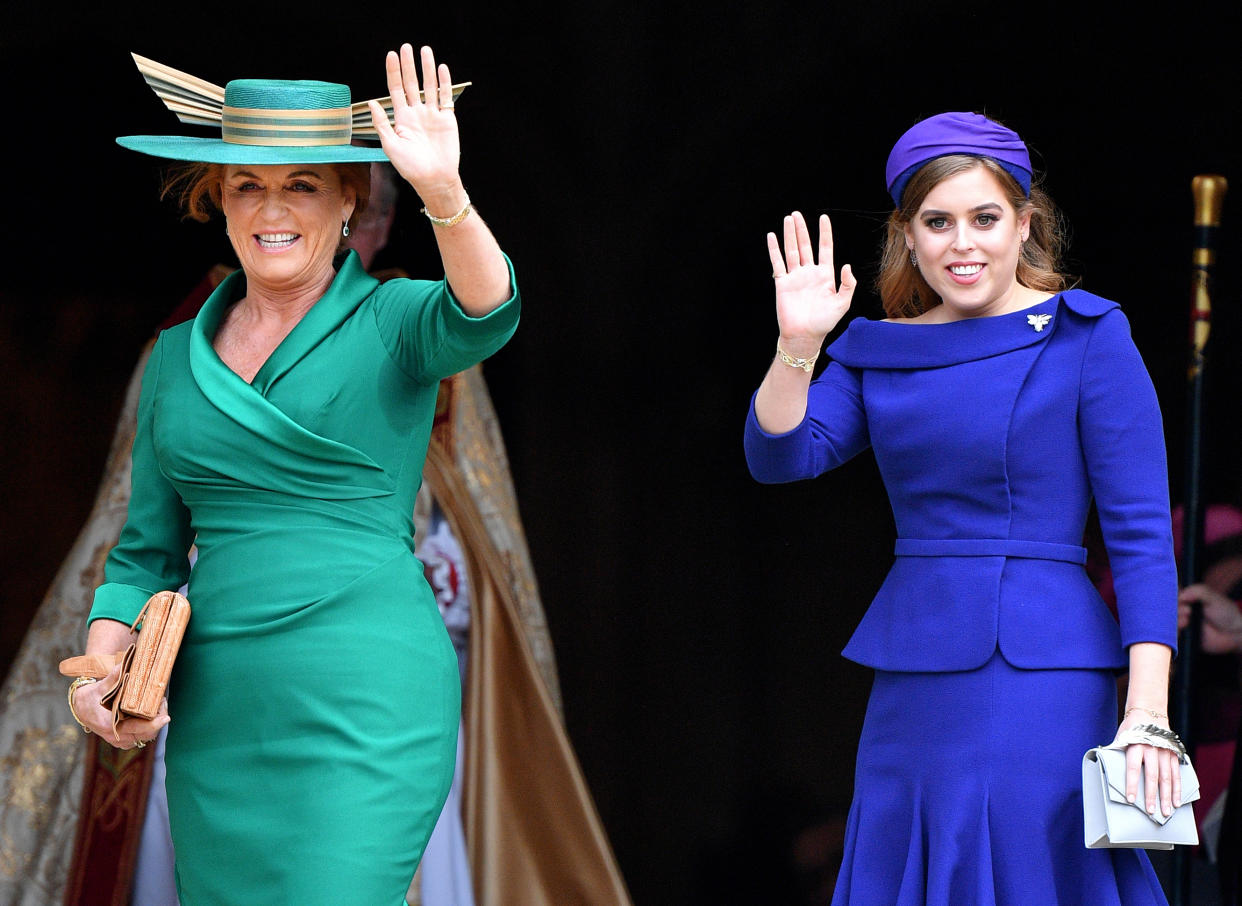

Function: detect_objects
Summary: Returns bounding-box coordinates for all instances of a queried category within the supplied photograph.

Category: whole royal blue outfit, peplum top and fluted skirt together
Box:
[745,290,1177,906]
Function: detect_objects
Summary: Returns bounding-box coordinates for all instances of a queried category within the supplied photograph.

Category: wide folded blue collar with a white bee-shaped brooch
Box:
[827,290,1117,368]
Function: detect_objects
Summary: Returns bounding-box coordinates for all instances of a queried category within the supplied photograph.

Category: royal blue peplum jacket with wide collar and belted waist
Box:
[745,290,1177,671]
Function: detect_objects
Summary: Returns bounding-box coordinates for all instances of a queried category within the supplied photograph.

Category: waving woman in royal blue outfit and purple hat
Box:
[745,113,1180,906]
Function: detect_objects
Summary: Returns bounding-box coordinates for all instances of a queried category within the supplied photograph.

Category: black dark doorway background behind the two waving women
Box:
[0,0,1242,904]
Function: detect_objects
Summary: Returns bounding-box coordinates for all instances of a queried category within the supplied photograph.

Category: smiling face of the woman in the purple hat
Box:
[905,164,1031,318]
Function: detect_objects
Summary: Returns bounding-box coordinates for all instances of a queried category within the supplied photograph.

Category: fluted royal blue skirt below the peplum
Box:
[832,652,1167,906]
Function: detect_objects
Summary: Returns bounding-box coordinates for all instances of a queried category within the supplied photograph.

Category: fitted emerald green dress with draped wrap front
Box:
[91,252,519,906]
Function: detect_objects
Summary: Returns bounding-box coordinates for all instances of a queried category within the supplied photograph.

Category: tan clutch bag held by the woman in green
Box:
[60,592,190,730]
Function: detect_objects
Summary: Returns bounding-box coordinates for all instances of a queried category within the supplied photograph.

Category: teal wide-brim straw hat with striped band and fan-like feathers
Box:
[117,53,469,164]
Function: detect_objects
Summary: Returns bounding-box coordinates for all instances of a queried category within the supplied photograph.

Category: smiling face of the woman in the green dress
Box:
[221,164,355,293]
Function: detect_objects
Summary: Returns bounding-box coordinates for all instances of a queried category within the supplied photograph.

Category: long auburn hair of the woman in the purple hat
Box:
[876,154,1069,318]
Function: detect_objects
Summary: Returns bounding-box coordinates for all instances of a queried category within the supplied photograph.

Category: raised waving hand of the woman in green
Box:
[370,43,461,200]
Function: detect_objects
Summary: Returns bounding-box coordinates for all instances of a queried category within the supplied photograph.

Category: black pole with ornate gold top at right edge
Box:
[1170,174,1228,906]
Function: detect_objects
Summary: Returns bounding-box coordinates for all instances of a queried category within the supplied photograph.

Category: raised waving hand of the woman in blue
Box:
[768,211,858,347]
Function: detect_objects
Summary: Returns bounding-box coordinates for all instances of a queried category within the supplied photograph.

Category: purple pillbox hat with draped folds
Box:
[884,113,1031,208]
